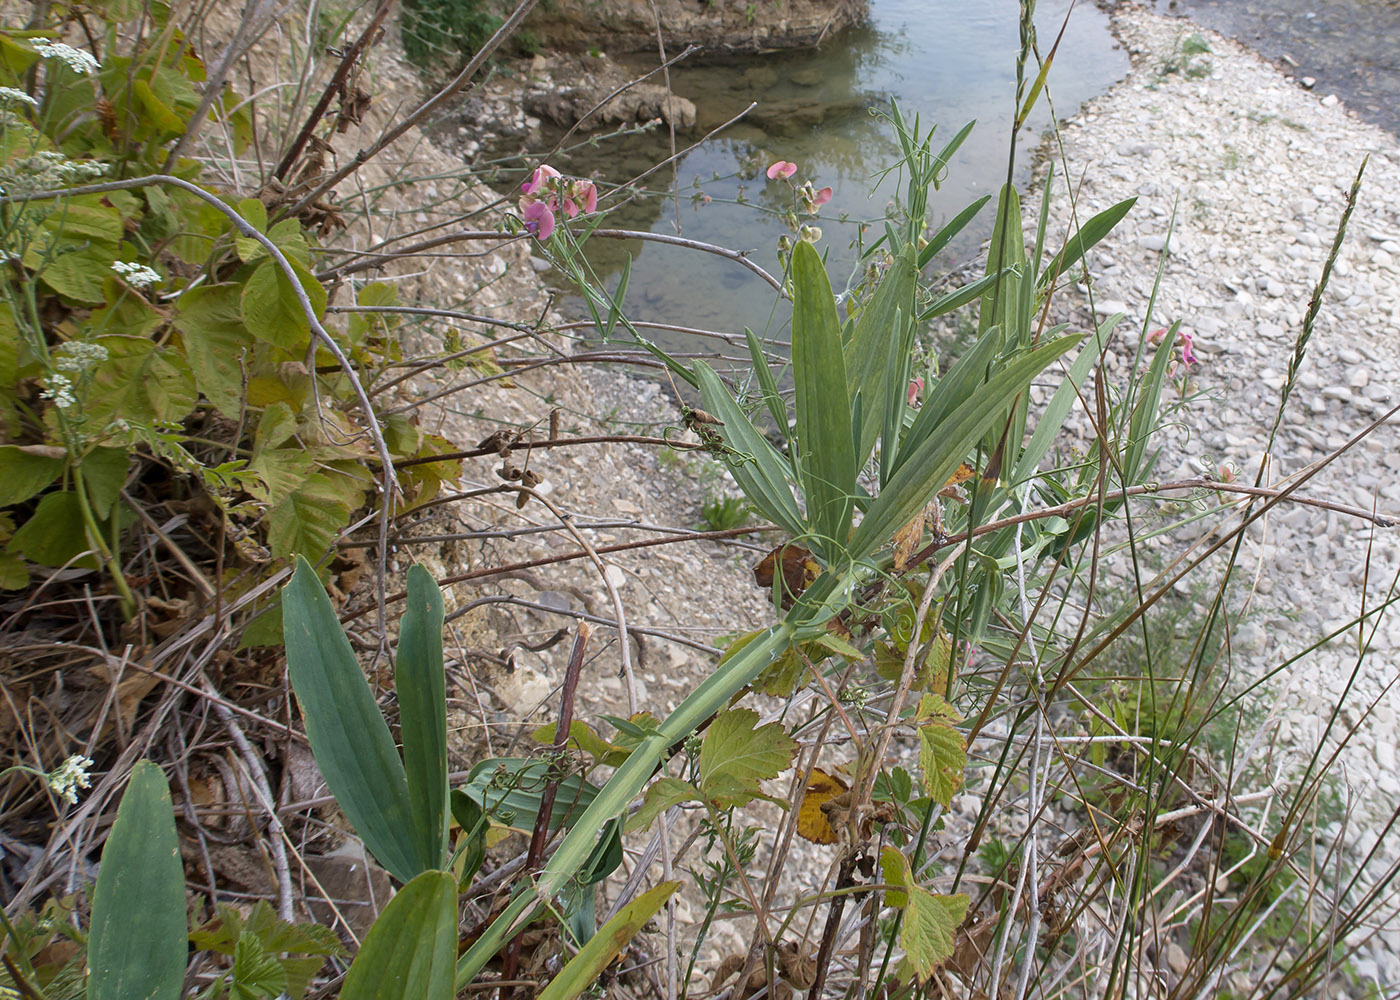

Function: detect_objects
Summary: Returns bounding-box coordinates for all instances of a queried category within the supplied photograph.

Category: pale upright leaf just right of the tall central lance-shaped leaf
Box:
[846,246,918,468]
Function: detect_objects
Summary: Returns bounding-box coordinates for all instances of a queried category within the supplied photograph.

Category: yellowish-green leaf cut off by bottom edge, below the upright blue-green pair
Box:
[340,871,456,1000]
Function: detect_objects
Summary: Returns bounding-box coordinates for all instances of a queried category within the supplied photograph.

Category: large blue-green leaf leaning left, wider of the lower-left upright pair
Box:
[283,557,420,879]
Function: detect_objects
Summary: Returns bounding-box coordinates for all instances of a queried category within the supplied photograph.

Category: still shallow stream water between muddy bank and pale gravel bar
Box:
[534,0,1128,350]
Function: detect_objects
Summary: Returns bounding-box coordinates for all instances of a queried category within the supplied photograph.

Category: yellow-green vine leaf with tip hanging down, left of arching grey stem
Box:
[175,283,253,417]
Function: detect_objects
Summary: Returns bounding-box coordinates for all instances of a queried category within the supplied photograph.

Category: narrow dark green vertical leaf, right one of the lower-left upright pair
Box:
[393,564,448,866]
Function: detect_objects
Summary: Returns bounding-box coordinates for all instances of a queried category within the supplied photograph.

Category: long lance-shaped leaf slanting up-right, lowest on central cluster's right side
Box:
[850,335,1082,559]
